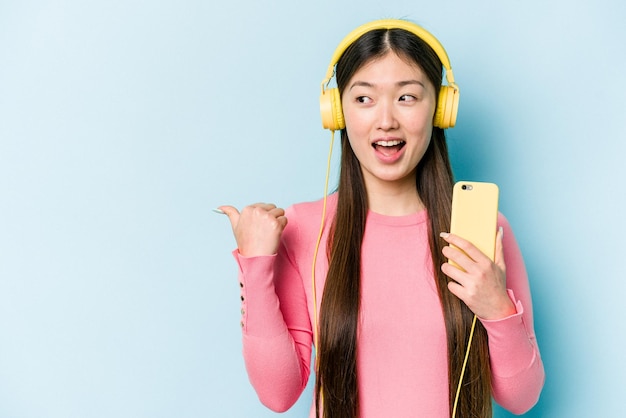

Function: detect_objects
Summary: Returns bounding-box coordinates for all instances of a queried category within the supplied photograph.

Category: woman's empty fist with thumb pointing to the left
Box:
[219,203,287,257]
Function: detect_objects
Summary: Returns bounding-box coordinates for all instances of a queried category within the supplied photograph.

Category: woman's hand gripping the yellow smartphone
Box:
[441,229,516,320]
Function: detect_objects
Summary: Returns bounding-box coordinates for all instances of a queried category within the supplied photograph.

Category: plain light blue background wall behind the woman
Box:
[0,0,626,418]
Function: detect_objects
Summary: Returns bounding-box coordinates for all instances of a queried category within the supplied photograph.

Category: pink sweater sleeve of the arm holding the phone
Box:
[481,215,545,414]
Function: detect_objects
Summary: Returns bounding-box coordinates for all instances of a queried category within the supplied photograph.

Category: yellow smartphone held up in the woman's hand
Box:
[450,181,499,267]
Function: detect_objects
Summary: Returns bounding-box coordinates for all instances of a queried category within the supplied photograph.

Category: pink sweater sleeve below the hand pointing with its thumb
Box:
[233,216,312,412]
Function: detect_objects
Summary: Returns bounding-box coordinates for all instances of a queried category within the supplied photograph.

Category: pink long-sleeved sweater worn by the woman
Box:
[234,195,544,418]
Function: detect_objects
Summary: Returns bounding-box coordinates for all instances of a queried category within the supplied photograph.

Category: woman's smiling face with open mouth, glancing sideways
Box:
[341,52,436,193]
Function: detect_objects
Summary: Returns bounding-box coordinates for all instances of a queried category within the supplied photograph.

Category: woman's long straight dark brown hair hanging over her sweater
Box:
[315,29,492,418]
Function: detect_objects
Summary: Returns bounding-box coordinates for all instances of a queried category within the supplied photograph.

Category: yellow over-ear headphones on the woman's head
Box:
[320,19,459,131]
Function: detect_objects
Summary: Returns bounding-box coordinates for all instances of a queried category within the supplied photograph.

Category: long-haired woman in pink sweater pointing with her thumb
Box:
[219,20,544,418]
